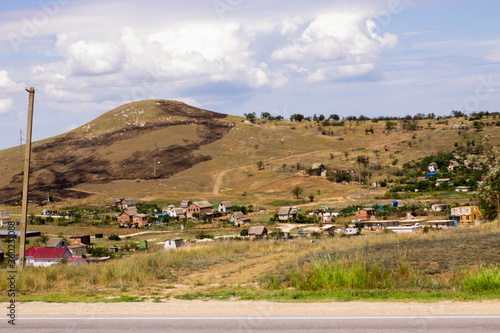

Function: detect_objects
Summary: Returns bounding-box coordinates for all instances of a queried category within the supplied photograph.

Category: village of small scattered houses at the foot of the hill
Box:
[0,188,483,266]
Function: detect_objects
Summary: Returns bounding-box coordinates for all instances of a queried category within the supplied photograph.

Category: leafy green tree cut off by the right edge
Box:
[476,137,500,228]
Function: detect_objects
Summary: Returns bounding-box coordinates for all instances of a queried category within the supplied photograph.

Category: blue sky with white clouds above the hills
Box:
[0,0,500,149]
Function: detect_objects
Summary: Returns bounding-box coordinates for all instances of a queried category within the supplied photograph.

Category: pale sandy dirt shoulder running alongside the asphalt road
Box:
[8,299,500,321]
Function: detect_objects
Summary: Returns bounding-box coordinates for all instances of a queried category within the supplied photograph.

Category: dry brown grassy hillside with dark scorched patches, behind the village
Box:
[0,100,500,210]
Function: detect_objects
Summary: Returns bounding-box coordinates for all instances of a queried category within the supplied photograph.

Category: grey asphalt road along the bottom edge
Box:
[0,315,500,333]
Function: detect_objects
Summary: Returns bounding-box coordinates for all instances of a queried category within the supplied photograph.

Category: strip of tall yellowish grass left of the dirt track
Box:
[0,241,288,293]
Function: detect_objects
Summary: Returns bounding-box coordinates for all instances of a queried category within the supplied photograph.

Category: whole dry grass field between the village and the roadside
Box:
[0,229,500,298]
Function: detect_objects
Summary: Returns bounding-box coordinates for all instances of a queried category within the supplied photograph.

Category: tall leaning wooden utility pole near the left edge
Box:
[19,87,35,269]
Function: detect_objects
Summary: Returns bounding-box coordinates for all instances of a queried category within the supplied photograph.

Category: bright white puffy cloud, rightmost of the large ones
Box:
[272,11,398,80]
